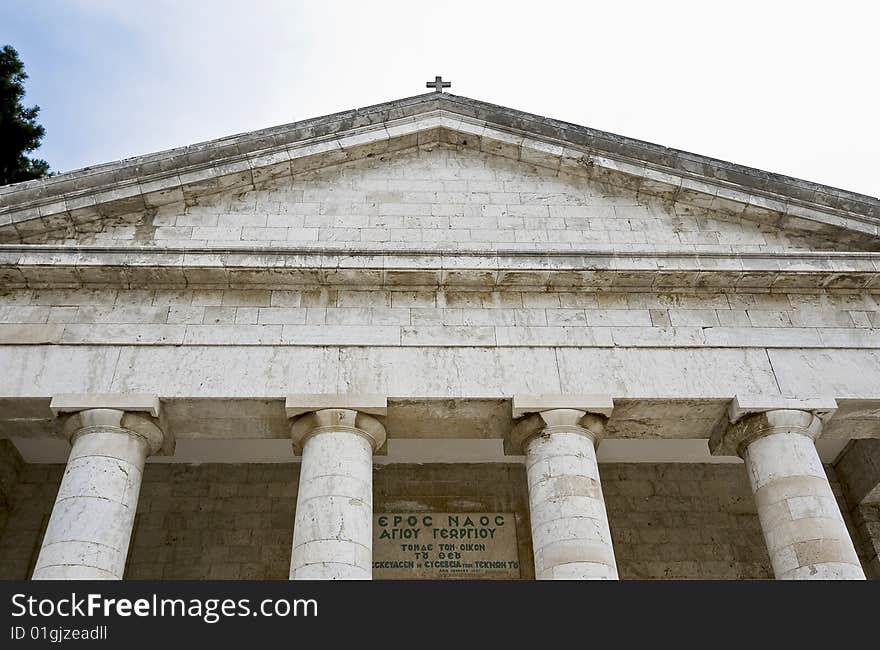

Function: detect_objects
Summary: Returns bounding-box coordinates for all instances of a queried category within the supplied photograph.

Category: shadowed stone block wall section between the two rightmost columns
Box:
[599,463,773,580]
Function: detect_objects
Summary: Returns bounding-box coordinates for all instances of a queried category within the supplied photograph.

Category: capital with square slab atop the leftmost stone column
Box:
[49,393,174,456]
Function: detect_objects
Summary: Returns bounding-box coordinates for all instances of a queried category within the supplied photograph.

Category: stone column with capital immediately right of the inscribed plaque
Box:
[506,396,618,580]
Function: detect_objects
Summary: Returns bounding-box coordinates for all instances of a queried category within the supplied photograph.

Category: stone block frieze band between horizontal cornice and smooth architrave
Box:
[0,286,880,350]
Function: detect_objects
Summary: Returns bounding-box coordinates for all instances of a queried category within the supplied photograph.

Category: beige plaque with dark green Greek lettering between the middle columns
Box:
[373,512,520,580]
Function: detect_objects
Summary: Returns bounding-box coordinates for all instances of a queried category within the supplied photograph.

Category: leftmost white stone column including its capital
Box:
[33,396,164,580]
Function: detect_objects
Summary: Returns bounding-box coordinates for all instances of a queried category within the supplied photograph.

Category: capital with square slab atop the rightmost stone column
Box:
[709,396,837,457]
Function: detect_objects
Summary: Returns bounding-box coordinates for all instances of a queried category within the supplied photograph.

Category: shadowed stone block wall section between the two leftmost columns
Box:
[126,464,299,580]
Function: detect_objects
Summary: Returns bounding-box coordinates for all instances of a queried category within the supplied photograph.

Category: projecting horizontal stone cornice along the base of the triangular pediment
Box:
[0,244,880,291]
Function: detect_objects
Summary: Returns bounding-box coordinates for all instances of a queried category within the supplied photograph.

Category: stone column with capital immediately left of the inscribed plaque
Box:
[287,396,385,580]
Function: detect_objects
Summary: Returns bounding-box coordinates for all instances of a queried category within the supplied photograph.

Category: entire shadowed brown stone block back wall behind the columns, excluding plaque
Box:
[0,463,880,579]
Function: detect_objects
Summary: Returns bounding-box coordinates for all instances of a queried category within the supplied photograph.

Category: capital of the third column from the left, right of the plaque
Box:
[504,395,614,456]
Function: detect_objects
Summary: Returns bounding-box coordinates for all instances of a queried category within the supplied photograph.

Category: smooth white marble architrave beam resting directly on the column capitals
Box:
[0,345,880,399]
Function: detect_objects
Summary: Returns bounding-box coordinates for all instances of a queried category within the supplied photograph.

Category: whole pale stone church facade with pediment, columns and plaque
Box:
[0,87,880,580]
